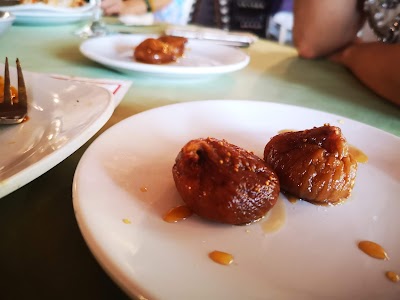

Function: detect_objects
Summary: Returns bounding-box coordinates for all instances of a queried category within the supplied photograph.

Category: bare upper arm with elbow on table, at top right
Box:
[293,0,364,58]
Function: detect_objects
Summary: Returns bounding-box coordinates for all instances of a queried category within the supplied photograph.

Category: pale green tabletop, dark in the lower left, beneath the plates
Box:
[0,19,400,299]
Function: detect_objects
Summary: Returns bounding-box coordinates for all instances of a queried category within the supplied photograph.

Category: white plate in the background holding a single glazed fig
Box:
[80,34,250,78]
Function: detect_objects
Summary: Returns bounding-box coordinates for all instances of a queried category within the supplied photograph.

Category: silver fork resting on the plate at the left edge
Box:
[0,58,28,124]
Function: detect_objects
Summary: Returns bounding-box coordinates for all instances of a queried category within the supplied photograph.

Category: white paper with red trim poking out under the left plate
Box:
[50,74,132,107]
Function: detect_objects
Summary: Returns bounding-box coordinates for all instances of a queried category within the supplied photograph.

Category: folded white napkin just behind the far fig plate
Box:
[165,25,258,46]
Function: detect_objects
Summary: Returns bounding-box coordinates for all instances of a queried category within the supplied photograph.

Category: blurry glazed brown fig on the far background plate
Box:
[134,36,187,64]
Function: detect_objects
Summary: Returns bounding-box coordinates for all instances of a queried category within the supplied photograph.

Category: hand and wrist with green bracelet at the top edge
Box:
[102,0,171,15]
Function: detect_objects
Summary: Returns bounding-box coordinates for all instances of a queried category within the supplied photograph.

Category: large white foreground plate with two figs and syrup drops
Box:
[73,100,400,300]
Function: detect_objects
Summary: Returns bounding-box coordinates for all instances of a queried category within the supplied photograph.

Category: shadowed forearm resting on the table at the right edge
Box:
[331,42,400,105]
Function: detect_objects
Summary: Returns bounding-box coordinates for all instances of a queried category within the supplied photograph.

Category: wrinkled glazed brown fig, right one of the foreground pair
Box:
[264,124,357,204]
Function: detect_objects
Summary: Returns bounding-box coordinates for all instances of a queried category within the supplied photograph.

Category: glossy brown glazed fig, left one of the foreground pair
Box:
[172,138,279,225]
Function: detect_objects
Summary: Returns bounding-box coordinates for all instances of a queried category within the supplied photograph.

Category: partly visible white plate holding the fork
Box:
[0,62,114,197]
